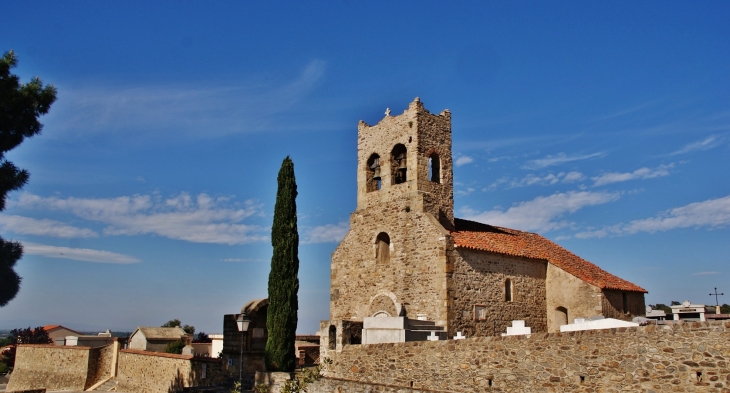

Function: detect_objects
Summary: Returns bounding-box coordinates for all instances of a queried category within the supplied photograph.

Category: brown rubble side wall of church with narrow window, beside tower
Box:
[448,248,547,337]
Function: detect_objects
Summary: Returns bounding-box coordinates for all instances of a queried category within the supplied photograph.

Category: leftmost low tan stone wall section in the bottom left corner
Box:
[7,344,90,391]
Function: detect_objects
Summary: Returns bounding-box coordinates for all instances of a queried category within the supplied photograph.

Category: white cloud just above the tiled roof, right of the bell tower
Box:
[462,191,619,232]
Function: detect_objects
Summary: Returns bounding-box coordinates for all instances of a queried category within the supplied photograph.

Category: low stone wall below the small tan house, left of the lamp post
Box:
[117,349,223,393]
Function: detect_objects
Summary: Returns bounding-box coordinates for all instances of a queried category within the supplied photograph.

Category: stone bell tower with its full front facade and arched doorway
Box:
[320,98,454,356]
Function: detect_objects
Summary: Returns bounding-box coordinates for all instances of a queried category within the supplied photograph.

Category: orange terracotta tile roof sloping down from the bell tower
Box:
[451,218,648,293]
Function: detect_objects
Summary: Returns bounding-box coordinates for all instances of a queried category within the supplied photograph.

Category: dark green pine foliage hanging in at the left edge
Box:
[0,51,56,307]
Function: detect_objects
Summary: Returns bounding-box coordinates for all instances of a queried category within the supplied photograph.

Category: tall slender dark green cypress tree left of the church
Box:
[265,156,299,372]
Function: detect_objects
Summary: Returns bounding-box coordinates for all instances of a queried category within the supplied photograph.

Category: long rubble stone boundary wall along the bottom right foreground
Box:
[310,322,730,393]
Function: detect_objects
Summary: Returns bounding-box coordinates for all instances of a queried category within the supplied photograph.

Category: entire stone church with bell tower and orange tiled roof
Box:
[320,98,647,356]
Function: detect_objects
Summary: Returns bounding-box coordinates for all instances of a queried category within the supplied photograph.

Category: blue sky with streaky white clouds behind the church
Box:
[0,1,730,333]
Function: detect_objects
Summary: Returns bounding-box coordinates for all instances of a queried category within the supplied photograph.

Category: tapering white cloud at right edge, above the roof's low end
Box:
[575,195,730,239]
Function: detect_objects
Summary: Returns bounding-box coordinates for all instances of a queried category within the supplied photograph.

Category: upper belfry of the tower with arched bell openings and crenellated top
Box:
[357,97,454,228]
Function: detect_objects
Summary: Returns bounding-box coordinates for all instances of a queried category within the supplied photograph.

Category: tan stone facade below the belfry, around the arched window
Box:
[330,204,451,325]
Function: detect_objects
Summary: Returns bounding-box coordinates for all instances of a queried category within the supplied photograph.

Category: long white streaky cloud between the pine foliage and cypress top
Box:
[16,193,267,245]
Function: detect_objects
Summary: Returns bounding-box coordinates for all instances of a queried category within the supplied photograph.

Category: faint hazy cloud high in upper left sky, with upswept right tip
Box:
[44,60,326,137]
